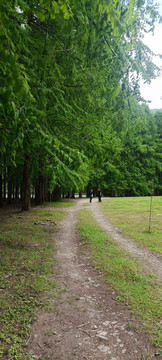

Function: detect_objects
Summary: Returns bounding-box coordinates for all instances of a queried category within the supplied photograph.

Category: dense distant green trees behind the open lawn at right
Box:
[90,99,162,196]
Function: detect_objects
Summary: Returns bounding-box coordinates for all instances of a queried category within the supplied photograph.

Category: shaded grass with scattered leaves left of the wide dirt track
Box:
[0,209,65,360]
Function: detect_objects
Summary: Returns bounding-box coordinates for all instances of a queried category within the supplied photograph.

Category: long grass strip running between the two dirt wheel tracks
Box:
[78,210,162,352]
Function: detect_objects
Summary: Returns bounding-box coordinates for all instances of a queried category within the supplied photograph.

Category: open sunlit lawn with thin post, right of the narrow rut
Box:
[101,196,162,254]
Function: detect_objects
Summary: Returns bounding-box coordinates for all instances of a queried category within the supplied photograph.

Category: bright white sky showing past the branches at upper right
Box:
[140,0,162,109]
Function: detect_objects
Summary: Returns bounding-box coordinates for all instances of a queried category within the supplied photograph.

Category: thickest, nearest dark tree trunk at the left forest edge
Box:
[22,155,31,211]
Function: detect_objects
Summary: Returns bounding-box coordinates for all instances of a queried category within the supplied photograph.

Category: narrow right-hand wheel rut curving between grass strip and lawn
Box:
[90,200,162,281]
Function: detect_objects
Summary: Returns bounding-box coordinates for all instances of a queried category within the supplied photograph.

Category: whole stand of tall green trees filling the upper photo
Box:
[0,0,162,210]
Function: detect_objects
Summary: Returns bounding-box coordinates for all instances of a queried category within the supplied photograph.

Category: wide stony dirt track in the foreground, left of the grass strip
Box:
[27,200,161,360]
